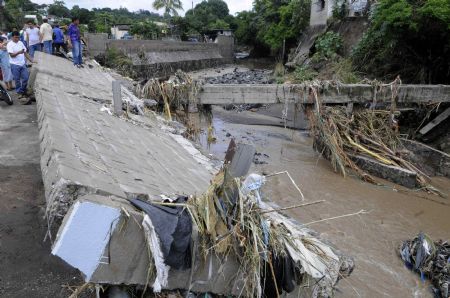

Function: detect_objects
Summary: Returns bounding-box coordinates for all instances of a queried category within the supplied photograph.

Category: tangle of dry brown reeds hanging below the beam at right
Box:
[308,95,439,193]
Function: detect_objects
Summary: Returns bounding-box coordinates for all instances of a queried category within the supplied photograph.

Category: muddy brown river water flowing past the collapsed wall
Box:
[200,108,450,297]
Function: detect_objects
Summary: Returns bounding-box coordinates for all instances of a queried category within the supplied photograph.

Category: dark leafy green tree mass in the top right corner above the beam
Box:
[353,0,450,83]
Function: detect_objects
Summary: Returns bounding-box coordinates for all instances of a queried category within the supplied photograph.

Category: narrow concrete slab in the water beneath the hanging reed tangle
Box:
[350,155,417,188]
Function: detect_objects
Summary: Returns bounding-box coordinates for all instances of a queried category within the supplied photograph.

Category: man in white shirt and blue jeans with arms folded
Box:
[6,31,33,97]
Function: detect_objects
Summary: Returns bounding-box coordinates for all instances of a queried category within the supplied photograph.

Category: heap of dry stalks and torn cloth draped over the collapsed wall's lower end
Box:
[133,170,353,297]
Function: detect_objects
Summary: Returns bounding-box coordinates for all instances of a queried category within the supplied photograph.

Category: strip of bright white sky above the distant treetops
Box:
[32,0,252,15]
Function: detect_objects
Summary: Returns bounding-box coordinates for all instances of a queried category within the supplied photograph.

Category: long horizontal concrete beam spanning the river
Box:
[199,84,450,105]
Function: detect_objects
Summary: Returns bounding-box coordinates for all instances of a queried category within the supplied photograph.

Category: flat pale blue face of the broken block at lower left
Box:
[52,202,120,281]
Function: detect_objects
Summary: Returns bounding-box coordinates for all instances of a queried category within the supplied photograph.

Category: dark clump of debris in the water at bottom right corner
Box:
[400,233,450,298]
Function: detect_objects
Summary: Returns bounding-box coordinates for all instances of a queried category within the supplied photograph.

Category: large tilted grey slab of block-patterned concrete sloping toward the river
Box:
[34,53,212,224]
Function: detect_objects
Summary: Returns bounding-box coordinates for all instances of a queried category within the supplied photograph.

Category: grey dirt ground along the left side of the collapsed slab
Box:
[0,102,82,298]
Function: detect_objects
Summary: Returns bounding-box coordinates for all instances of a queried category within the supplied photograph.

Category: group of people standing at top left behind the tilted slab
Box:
[0,17,83,98]
